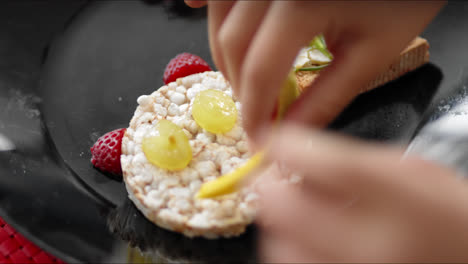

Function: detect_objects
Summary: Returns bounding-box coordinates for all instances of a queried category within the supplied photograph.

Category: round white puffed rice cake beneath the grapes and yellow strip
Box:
[121,72,257,238]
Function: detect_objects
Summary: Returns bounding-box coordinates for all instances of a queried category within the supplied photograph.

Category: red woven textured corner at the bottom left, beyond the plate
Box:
[0,218,64,263]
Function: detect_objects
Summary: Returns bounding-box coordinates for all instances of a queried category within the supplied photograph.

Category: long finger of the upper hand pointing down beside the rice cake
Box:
[239,1,322,143]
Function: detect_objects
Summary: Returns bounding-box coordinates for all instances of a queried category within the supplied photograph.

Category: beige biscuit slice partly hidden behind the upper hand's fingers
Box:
[296,37,429,92]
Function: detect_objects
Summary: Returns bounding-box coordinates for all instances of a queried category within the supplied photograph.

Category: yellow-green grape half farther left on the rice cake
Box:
[142,120,192,171]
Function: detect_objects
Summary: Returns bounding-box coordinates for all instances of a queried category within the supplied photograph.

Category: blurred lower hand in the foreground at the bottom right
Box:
[259,125,468,263]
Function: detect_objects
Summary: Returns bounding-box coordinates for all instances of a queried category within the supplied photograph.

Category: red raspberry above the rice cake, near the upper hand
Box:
[163,53,211,84]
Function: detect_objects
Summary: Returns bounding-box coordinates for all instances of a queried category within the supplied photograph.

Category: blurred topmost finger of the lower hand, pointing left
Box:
[268,125,401,191]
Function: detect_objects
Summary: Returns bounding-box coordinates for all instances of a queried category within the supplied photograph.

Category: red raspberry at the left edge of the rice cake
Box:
[91,128,126,176]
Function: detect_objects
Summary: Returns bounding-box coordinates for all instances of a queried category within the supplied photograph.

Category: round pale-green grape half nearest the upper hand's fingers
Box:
[192,89,237,134]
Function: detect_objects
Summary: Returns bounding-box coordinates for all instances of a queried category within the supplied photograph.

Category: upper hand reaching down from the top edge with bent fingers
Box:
[186,0,444,143]
